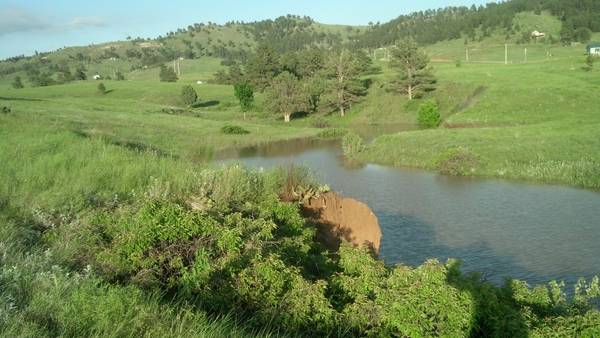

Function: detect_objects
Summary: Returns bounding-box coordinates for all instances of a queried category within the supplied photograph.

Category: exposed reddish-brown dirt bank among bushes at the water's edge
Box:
[303,192,381,253]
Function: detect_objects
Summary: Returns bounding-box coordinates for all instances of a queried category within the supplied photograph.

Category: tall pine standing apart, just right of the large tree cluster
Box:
[390,39,436,100]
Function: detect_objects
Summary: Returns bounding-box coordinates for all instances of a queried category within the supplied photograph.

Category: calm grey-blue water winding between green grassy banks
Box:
[218,140,600,285]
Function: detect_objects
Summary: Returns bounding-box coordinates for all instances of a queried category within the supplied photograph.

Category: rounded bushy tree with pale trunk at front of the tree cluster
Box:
[267,72,307,123]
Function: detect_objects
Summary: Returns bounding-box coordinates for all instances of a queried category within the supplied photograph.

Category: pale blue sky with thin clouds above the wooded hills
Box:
[0,0,491,58]
